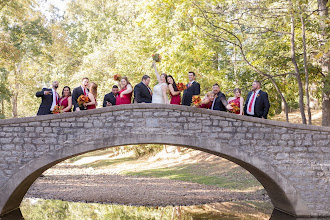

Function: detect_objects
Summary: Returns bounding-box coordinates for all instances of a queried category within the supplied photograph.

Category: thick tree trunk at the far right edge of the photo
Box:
[317,0,330,126]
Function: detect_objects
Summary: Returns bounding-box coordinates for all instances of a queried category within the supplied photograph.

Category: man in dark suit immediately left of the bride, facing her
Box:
[134,75,152,103]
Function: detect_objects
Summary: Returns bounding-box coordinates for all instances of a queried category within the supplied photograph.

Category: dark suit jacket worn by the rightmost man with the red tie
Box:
[244,90,270,118]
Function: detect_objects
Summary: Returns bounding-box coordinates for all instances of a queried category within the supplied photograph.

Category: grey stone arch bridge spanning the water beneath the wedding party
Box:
[0,104,330,217]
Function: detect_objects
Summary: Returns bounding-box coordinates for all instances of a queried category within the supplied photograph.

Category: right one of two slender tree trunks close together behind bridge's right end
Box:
[300,14,312,125]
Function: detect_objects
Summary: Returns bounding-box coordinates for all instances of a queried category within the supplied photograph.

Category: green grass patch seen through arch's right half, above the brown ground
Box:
[123,164,260,190]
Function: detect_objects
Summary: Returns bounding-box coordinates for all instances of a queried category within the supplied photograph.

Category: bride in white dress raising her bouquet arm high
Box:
[152,61,170,104]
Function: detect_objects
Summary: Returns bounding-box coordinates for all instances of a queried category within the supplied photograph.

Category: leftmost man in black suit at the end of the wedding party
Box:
[36,81,60,115]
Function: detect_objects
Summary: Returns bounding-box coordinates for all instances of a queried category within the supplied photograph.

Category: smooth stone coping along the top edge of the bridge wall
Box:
[0,103,330,132]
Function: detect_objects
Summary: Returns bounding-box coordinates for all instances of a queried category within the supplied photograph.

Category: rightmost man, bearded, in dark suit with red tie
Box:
[244,81,270,119]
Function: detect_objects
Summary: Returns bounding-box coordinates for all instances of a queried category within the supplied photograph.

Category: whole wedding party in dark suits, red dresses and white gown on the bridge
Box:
[36,61,270,119]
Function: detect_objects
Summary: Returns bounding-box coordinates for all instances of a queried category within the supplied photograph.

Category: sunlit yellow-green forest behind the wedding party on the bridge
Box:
[0,0,330,126]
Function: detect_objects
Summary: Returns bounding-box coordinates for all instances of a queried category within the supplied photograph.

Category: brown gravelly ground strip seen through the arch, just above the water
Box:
[26,175,266,206]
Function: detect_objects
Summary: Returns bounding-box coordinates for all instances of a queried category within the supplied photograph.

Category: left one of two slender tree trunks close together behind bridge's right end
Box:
[291,14,306,124]
